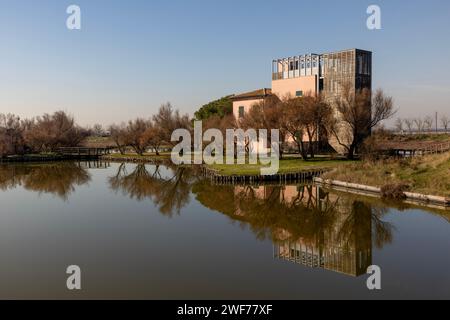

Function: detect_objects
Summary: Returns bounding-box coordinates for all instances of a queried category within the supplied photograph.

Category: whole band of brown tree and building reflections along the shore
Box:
[0,162,444,276]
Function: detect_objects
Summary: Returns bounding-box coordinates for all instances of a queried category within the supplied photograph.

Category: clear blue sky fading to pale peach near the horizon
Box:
[0,0,450,125]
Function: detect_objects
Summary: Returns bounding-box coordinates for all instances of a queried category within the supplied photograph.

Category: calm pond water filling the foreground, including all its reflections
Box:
[0,162,450,299]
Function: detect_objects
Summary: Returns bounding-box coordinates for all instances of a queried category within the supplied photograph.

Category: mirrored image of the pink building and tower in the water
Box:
[234,186,372,276]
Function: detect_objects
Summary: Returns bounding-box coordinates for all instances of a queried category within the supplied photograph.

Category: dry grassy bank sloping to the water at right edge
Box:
[324,153,450,197]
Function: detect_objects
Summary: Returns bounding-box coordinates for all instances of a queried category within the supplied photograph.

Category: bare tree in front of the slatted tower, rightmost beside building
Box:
[330,85,396,159]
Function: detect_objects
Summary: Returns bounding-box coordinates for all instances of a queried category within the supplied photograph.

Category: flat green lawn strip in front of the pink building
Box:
[209,157,353,176]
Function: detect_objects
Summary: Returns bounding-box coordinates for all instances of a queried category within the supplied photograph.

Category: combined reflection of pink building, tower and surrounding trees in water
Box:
[193,183,393,276]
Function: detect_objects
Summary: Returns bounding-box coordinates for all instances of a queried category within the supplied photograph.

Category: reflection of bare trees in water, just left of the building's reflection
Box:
[109,163,194,216]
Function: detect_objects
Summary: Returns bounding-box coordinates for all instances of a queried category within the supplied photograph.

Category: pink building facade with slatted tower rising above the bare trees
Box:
[233,49,372,152]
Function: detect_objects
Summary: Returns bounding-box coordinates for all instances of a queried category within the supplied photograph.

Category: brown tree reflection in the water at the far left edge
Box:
[0,162,91,200]
